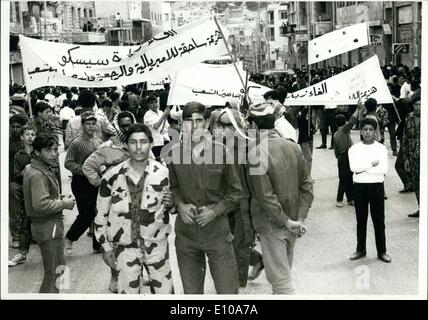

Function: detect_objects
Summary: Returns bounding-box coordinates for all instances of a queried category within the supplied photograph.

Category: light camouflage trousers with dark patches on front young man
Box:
[115,239,174,294]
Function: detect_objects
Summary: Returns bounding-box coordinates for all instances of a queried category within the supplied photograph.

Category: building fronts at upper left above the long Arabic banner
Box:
[9,1,152,85]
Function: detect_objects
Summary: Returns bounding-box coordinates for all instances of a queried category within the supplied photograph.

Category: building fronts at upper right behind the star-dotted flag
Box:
[285,1,422,69]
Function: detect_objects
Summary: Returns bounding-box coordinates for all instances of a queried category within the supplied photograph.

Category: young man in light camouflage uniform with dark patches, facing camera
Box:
[95,124,174,294]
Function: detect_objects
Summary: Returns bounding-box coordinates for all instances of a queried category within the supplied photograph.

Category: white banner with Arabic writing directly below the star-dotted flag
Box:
[285,55,393,106]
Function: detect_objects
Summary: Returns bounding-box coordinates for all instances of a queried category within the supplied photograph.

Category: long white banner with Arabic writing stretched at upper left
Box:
[20,18,227,92]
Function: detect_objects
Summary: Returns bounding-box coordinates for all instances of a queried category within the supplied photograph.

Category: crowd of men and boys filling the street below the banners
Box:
[9,58,420,294]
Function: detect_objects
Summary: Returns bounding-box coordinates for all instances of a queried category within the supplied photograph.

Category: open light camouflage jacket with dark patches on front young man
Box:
[95,159,171,251]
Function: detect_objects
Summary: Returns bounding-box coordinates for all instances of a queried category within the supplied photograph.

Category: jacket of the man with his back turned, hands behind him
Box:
[247,130,313,234]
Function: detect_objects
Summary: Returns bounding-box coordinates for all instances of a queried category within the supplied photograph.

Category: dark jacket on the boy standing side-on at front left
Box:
[23,158,63,222]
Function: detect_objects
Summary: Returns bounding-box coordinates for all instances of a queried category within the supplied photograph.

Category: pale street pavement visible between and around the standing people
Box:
[8,131,419,295]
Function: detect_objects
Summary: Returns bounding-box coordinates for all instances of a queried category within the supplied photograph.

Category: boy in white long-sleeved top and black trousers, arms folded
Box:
[348,118,391,263]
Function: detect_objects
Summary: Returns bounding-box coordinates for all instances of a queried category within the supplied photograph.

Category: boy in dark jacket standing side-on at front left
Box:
[23,133,74,293]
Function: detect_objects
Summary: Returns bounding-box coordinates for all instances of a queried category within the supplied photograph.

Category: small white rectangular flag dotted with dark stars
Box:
[308,22,369,64]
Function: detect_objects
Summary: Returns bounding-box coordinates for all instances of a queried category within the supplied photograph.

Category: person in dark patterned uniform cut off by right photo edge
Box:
[400,94,421,218]
